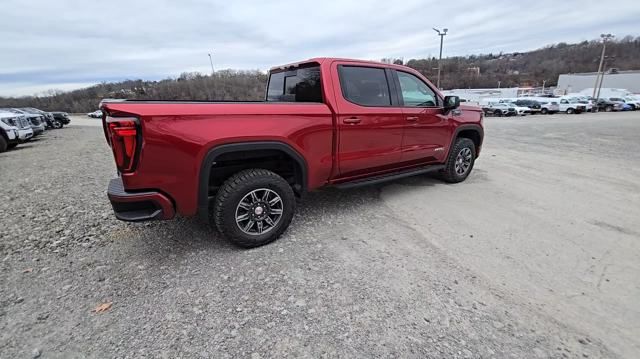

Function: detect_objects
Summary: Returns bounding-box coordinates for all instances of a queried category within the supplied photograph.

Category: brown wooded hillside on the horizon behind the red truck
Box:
[0,36,640,112]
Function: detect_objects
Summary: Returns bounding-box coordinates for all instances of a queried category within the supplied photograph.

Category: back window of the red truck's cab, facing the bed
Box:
[267,65,322,102]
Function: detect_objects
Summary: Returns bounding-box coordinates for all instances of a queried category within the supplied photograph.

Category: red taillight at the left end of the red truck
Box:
[106,117,140,173]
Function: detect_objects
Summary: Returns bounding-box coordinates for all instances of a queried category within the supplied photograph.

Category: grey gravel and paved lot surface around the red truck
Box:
[0,113,640,358]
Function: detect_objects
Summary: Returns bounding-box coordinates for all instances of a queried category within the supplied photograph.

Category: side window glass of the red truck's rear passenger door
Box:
[339,66,391,106]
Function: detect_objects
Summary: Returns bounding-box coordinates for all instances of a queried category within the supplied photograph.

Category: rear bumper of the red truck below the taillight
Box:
[107,178,176,222]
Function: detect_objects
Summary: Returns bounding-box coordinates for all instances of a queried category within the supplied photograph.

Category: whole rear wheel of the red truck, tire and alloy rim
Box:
[213,168,296,248]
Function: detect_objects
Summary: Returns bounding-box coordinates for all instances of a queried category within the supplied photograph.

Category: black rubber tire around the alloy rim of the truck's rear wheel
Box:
[213,168,296,248]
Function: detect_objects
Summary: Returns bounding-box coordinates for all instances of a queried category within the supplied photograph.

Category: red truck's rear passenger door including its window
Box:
[332,62,405,177]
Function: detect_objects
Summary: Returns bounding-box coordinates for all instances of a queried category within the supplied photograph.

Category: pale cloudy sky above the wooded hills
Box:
[0,0,640,96]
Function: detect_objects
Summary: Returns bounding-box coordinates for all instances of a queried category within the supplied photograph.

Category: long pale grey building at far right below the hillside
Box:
[557,70,640,93]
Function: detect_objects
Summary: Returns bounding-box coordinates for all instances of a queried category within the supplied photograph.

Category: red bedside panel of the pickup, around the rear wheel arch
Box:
[104,103,333,216]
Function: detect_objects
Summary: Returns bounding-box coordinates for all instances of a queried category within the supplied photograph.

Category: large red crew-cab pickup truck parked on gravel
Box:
[101,58,484,247]
